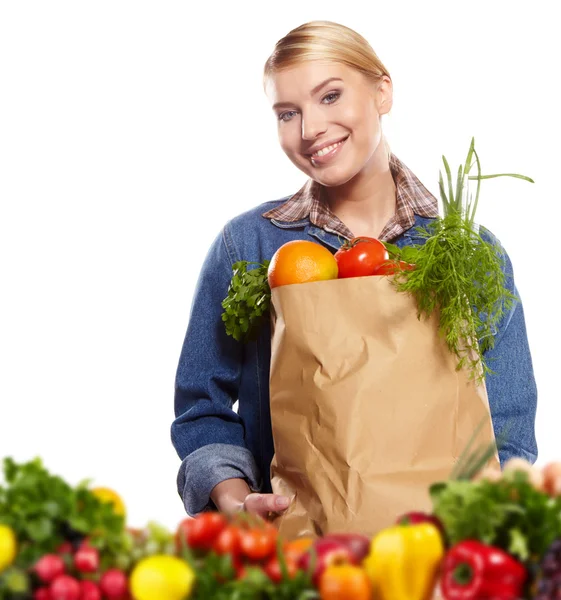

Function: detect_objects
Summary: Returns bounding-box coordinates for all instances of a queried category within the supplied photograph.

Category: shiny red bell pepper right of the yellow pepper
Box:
[441,540,527,600]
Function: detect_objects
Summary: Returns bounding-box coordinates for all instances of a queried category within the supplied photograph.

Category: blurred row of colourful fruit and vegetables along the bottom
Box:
[0,455,561,600]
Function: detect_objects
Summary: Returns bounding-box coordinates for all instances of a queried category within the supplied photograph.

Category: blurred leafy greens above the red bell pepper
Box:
[430,471,561,562]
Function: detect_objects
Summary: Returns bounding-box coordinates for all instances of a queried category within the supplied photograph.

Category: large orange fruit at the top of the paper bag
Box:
[268,240,339,289]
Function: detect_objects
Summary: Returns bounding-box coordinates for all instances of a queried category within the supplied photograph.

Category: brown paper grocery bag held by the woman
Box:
[270,277,500,539]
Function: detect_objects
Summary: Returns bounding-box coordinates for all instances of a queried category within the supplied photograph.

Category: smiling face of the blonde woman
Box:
[266,61,392,187]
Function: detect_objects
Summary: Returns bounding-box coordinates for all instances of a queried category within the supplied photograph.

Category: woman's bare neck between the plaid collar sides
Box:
[324,144,396,237]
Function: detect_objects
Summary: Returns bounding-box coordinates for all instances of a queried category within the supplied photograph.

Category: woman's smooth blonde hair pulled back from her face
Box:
[263,21,391,155]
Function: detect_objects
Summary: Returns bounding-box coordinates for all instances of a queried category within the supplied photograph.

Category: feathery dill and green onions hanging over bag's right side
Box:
[386,138,533,380]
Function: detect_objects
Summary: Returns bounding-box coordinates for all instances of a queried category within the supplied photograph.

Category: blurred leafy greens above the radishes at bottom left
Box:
[0,458,124,568]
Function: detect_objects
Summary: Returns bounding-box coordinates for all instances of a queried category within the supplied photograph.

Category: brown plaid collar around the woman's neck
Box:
[263,154,438,241]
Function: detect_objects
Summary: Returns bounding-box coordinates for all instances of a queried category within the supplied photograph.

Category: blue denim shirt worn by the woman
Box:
[171,196,537,515]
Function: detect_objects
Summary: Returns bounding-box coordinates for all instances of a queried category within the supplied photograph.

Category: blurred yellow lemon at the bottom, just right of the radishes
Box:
[130,554,195,600]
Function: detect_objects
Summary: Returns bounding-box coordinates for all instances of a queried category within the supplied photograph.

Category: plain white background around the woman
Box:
[0,0,561,527]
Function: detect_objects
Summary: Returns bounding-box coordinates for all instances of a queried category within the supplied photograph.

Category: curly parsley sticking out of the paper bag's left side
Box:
[222,260,271,342]
